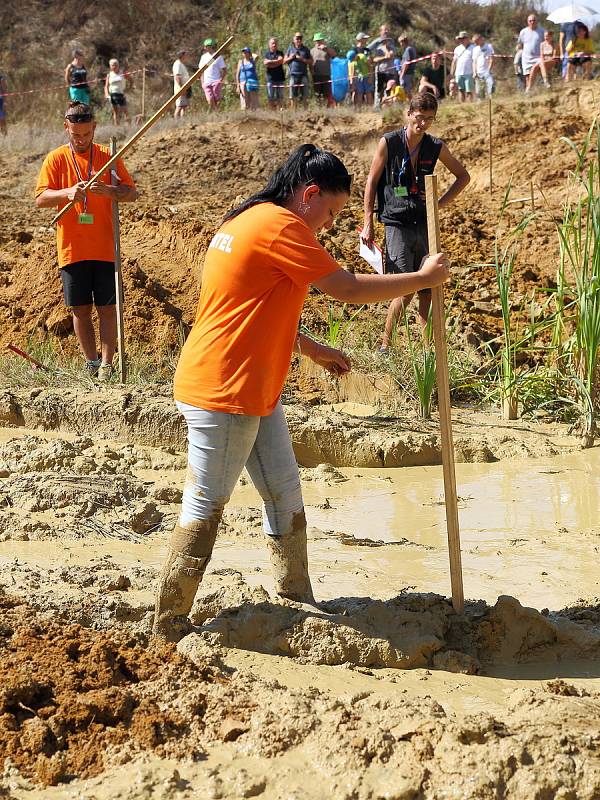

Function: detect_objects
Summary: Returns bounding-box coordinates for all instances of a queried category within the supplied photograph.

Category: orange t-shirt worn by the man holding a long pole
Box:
[35,144,135,267]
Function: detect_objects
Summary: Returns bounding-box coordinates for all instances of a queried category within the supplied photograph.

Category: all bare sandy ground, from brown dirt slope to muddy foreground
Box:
[0,86,600,800]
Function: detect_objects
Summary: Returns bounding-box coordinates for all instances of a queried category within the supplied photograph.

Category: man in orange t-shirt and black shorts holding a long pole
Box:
[35,103,137,380]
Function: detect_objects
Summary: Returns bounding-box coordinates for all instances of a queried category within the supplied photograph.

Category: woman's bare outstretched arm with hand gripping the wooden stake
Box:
[315,253,449,303]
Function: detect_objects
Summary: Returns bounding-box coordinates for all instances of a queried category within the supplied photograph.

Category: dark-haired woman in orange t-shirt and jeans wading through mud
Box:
[153,145,448,641]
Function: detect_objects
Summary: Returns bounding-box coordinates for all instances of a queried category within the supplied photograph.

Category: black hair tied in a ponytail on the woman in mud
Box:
[223,144,352,222]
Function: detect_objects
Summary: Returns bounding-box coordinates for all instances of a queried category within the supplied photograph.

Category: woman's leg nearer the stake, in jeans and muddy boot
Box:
[246,403,314,602]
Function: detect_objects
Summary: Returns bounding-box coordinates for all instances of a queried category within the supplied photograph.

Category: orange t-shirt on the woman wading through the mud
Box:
[174,203,340,416]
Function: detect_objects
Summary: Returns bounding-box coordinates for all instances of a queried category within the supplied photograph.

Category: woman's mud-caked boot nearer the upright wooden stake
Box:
[267,511,315,603]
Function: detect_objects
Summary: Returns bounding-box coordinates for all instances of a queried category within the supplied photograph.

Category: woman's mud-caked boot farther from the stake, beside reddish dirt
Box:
[152,519,219,642]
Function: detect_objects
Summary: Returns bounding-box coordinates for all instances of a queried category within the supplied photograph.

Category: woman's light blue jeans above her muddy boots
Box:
[177,402,304,536]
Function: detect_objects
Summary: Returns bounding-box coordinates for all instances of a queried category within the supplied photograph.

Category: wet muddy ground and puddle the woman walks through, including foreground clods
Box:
[0,392,600,800]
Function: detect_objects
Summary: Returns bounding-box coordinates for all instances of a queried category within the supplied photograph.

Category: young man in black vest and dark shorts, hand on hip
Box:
[360,92,470,352]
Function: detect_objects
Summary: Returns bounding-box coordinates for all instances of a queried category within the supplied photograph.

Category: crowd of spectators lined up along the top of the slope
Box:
[0,13,595,133]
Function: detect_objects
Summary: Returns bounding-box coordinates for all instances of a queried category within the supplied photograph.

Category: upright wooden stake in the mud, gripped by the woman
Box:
[425,175,465,614]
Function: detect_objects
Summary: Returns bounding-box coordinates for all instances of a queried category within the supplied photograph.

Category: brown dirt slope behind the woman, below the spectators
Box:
[0,88,594,356]
